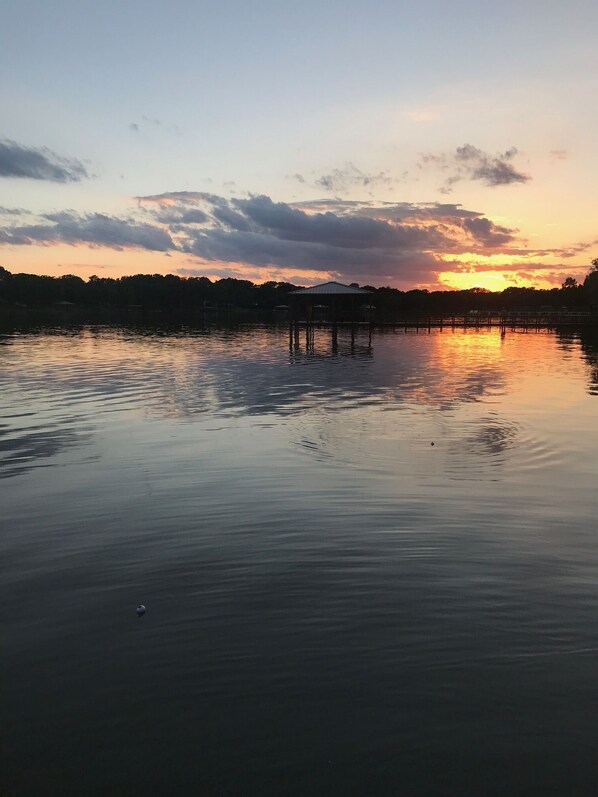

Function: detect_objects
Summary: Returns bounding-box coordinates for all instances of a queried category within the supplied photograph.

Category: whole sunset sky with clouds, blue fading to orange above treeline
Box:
[0,0,598,290]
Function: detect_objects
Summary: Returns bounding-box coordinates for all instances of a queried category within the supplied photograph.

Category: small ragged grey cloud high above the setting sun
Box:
[418,144,531,193]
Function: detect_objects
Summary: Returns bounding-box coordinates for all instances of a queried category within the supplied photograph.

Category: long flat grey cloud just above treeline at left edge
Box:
[0,211,175,252]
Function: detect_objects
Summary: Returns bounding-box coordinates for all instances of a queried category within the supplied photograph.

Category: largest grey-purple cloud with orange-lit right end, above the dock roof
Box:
[137,192,516,281]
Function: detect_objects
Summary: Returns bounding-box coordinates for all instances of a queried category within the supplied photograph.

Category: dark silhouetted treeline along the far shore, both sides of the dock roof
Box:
[0,267,598,316]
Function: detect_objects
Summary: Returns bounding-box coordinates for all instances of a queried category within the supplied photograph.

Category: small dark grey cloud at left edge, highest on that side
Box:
[0,139,89,183]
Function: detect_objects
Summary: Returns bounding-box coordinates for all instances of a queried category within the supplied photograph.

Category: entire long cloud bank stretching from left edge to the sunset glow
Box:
[0,191,520,285]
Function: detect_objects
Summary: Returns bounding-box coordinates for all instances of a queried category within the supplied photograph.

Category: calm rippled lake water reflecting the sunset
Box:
[0,328,598,797]
